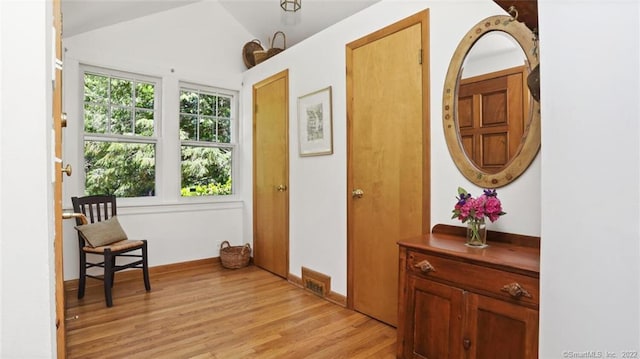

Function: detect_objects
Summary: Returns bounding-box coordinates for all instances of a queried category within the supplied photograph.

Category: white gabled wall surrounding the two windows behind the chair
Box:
[63,1,253,279]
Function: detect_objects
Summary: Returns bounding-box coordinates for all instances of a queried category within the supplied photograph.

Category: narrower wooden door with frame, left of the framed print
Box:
[253,71,289,278]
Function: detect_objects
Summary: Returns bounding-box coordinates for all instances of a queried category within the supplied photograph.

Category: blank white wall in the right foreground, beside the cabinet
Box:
[538,1,640,358]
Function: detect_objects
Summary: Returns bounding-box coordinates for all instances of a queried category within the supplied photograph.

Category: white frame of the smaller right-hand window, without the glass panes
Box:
[177,81,239,198]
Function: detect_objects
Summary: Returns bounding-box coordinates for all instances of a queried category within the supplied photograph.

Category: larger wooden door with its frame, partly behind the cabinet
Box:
[347,11,429,326]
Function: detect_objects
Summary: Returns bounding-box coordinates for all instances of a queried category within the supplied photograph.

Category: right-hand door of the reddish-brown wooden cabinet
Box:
[465,294,538,359]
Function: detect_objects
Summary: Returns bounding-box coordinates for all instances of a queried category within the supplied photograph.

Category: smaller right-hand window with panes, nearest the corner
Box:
[180,85,236,197]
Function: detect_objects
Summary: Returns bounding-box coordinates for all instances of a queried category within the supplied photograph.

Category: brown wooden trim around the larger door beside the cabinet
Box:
[346,9,431,309]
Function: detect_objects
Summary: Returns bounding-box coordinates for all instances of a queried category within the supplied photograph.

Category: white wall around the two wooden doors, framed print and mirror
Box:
[242,0,540,294]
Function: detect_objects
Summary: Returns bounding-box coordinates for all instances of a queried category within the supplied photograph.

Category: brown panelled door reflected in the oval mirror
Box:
[458,66,529,173]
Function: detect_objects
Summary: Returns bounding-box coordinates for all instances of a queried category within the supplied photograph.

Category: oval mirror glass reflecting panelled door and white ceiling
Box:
[458,31,529,173]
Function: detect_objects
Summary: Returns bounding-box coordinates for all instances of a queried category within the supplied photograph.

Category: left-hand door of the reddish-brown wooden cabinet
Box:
[404,277,463,358]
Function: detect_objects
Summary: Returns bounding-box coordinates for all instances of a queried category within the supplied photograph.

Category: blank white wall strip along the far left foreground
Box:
[0,0,56,359]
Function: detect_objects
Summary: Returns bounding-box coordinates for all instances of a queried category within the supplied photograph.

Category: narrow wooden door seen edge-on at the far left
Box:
[52,0,67,358]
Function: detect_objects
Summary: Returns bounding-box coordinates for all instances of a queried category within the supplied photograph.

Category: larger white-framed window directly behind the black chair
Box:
[83,68,160,197]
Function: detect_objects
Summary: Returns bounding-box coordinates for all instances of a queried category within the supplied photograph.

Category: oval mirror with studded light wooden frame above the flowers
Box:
[442,16,540,188]
